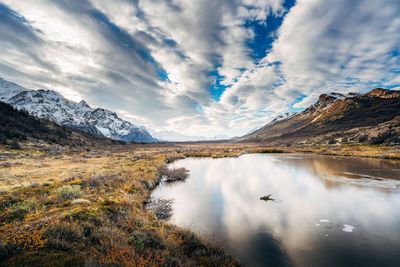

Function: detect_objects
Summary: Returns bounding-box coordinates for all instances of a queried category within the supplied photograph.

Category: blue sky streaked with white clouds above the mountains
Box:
[0,0,400,137]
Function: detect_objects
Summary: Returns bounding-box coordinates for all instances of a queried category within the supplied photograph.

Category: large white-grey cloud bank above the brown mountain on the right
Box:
[214,0,400,131]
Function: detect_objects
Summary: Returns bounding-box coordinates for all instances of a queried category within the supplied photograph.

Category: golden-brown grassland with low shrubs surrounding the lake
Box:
[0,144,400,266]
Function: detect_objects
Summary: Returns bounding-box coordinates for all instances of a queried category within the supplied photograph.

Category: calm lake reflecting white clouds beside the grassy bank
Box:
[152,154,400,266]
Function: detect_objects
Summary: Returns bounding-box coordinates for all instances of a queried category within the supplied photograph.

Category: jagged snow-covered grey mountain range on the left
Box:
[0,78,157,142]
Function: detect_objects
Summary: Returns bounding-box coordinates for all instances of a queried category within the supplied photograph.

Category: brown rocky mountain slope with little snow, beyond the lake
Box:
[241,88,400,145]
